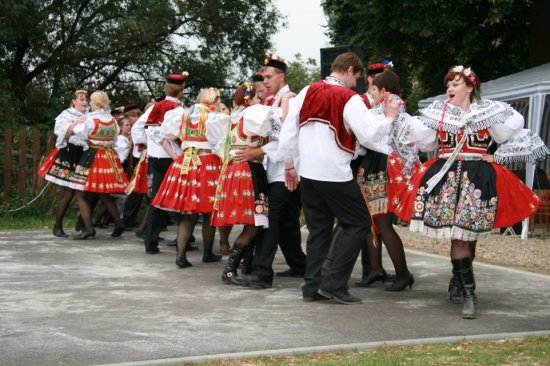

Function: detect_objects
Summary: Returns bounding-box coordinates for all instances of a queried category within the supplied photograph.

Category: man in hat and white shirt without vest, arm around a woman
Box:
[237,53,306,288]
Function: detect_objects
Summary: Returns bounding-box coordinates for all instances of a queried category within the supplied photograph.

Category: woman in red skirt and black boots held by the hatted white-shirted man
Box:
[212,83,271,286]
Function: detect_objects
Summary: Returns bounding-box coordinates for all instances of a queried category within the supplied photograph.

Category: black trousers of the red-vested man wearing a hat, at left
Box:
[145,157,172,250]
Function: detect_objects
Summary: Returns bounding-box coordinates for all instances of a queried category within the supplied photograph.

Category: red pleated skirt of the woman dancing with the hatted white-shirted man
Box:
[211,162,261,227]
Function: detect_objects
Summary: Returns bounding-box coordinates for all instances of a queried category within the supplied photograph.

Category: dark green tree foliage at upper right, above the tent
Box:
[322,0,550,112]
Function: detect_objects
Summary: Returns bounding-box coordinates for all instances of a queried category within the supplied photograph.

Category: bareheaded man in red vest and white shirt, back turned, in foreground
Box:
[277,52,401,304]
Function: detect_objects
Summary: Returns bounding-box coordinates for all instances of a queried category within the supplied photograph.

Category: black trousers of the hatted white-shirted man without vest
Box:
[252,182,306,282]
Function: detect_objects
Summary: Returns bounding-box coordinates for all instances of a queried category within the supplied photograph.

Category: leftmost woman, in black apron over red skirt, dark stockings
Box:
[38,90,88,238]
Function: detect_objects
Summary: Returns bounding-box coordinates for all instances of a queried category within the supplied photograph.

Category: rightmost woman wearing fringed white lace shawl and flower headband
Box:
[394,66,549,319]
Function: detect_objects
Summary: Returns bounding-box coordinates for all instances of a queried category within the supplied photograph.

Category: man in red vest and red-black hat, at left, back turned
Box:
[132,72,189,254]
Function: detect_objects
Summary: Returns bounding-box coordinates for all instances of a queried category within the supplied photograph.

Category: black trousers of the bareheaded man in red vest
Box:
[300,177,371,297]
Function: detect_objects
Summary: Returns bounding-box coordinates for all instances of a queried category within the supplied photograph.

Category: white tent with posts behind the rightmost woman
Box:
[418,63,550,239]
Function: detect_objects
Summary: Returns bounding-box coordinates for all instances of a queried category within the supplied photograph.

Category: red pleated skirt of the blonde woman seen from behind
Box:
[151,154,221,213]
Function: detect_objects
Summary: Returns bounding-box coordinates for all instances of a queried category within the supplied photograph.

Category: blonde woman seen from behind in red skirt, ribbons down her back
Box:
[151,88,229,268]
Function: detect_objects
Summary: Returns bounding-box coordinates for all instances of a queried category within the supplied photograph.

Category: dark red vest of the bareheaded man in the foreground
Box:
[300,81,357,154]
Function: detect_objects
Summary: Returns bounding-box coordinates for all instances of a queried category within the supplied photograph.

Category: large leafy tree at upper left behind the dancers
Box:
[0,0,280,129]
